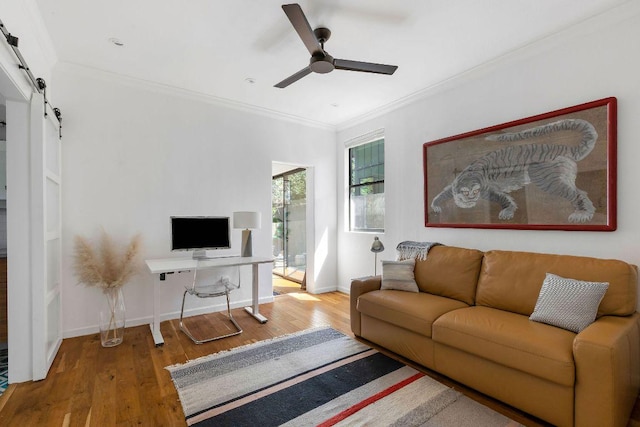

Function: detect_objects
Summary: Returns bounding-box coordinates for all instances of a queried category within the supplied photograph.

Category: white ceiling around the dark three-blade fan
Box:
[36,0,632,125]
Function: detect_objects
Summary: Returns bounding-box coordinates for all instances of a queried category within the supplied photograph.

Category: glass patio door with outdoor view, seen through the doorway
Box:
[271,168,307,283]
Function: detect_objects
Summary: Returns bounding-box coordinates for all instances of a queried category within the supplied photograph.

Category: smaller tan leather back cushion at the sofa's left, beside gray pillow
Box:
[415,246,482,305]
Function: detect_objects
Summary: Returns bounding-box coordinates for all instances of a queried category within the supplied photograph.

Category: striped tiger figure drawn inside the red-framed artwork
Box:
[431,119,598,223]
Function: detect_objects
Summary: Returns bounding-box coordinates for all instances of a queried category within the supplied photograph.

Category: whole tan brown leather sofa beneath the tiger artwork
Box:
[350,246,640,427]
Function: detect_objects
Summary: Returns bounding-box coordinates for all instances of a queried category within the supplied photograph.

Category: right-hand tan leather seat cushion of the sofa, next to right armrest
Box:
[432,306,576,386]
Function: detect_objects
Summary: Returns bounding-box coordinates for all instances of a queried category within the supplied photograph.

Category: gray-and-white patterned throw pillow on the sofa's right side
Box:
[529,273,609,333]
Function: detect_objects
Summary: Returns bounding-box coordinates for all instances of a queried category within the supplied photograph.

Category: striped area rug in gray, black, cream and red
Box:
[167,327,517,426]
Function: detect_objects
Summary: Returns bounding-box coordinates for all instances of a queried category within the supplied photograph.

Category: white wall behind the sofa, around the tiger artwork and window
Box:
[337,2,640,291]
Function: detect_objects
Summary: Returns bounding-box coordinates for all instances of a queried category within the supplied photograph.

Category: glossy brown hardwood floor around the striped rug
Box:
[0,292,640,427]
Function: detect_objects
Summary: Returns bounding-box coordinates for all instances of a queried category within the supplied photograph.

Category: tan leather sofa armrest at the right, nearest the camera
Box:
[573,313,640,427]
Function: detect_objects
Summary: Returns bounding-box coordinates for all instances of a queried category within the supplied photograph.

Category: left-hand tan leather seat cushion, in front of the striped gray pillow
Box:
[357,290,468,337]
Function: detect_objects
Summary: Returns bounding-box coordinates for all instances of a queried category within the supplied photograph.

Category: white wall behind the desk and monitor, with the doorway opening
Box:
[54,64,336,337]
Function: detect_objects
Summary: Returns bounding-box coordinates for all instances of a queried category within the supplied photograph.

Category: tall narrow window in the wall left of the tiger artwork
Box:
[349,138,384,232]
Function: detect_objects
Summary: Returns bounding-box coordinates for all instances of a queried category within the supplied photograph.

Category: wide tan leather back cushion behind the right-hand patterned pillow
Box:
[476,251,638,317]
